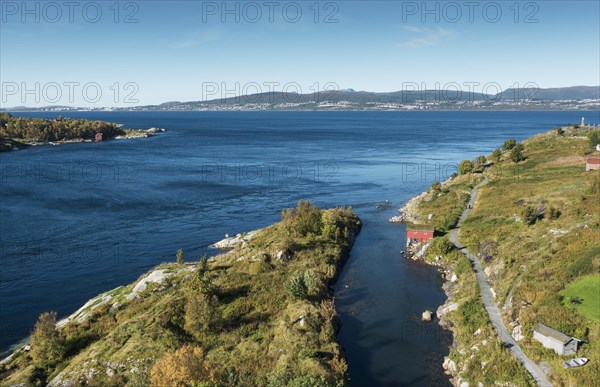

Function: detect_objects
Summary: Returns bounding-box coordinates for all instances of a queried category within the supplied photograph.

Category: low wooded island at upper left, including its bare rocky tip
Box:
[0,113,165,152]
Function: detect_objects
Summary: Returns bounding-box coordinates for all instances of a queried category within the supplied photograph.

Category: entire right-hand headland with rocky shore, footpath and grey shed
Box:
[394,126,600,386]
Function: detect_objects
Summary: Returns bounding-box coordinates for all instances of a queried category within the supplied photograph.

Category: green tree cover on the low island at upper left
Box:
[0,113,126,147]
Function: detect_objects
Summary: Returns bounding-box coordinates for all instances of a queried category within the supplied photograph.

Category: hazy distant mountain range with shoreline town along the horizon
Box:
[0,86,600,111]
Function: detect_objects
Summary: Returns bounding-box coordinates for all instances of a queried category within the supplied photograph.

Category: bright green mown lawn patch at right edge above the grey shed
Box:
[559,274,600,322]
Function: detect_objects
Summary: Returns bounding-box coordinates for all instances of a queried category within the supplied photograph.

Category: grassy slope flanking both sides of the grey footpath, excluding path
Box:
[415,127,600,386]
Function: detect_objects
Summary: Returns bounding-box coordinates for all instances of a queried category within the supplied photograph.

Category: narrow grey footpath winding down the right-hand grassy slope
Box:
[449,176,552,387]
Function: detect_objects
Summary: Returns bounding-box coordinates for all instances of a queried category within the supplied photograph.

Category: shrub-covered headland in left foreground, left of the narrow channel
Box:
[2,202,361,386]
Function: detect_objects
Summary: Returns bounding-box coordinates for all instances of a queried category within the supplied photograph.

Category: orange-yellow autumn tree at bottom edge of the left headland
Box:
[150,344,212,387]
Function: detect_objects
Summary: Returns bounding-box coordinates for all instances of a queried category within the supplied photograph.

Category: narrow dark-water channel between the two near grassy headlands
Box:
[335,204,452,386]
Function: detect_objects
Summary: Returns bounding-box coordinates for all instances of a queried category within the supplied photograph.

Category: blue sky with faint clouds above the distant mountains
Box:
[0,0,600,107]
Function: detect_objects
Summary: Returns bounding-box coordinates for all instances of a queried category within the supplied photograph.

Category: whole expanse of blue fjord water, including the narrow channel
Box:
[0,112,600,385]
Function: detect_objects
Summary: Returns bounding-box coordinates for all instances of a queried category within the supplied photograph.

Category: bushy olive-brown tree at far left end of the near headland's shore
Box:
[30,312,66,368]
